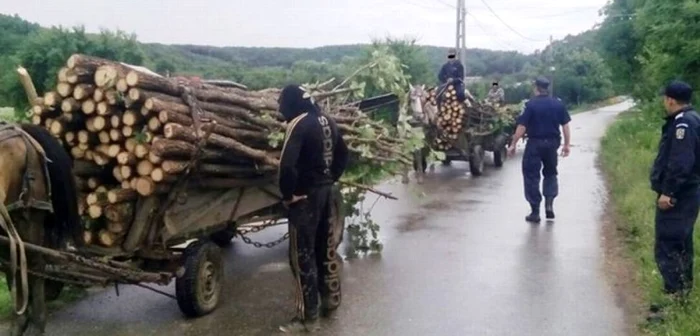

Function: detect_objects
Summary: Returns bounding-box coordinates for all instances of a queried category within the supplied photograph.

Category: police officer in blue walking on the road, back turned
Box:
[508,77,571,223]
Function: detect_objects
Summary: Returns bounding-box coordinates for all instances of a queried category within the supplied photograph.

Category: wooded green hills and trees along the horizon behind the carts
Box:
[0,11,613,116]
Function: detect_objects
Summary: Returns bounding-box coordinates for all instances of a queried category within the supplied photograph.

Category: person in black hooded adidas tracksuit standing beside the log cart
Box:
[279,84,348,332]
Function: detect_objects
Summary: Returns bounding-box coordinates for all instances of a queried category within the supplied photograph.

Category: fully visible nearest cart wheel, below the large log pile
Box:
[175,240,224,317]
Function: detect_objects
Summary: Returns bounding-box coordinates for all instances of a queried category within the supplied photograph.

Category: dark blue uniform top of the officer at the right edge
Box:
[650,107,700,197]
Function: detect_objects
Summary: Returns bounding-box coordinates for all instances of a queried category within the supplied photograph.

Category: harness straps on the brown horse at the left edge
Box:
[0,122,53,315]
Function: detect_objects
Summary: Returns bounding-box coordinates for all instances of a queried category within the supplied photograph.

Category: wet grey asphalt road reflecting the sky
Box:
[13,103,631,336]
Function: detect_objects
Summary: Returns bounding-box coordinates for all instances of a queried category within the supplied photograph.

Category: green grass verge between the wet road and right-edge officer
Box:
[601,108,700,336]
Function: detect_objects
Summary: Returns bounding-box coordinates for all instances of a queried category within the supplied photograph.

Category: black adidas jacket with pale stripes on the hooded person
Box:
[279,110,348,200]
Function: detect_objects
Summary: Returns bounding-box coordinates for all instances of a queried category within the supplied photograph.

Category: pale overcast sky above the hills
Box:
[0,0,606,53]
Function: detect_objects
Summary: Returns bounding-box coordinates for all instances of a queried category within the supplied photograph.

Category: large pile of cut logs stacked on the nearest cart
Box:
[32,54,410,247]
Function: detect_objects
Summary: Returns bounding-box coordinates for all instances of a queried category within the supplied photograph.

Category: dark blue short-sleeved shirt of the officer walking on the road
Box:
[517,95,571,141]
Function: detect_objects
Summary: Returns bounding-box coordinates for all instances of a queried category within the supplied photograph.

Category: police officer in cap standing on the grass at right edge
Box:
[650,81,700,314]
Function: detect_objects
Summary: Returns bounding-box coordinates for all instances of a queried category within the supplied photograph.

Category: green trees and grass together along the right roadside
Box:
[596,0,700,336]
